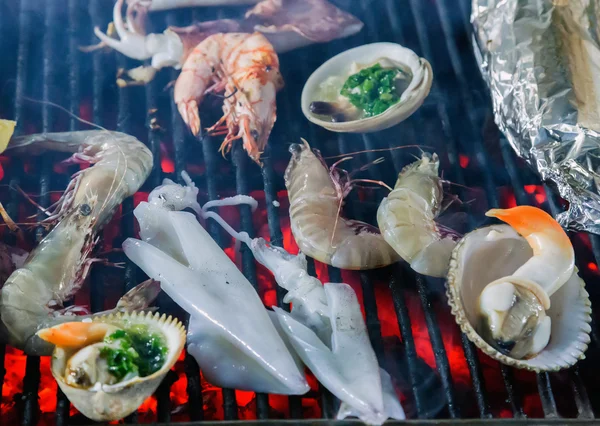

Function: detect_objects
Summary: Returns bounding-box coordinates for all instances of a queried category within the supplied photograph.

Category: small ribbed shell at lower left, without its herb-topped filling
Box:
[50,312,185,421]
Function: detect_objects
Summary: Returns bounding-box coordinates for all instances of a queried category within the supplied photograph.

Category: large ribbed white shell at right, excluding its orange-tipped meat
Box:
[446,225,592,372]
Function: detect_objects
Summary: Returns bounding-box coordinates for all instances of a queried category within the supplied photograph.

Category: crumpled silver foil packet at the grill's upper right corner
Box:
[471,0,600,234]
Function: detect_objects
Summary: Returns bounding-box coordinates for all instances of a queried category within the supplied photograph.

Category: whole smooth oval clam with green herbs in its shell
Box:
[301,43,433,133]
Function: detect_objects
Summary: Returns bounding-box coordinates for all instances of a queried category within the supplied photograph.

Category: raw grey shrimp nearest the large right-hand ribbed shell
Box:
[377,153,456,277]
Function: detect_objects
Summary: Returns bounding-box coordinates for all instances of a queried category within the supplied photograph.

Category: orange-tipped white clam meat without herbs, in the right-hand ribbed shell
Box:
[479,206,575,358]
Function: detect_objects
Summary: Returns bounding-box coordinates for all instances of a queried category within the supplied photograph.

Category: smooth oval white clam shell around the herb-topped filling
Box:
[301,43,433,133]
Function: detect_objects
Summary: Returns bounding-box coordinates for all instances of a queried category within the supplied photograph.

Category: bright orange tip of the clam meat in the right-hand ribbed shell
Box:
[485,206,573,254]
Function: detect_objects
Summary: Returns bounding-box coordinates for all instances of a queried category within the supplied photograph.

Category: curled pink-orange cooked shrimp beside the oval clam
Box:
[174,33,283,163]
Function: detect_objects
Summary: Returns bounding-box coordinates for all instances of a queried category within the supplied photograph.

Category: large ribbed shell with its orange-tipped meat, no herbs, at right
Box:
[447,206,591,371]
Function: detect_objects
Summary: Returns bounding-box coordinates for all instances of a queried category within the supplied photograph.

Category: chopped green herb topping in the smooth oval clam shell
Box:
[340,64,402,117]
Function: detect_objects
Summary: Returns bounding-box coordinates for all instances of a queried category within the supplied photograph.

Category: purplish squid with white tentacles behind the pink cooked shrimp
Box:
[94,0,363,69]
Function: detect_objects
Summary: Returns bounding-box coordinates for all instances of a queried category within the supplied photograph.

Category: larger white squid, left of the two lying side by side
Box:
[123,174,309,394]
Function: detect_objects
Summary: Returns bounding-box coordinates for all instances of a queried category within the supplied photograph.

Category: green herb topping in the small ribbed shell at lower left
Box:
[100,324,167,381]
